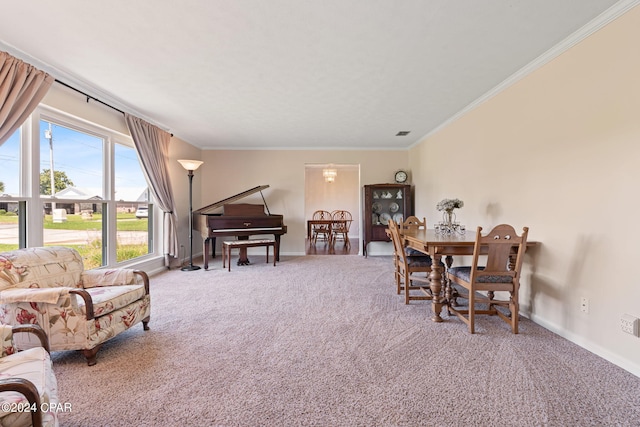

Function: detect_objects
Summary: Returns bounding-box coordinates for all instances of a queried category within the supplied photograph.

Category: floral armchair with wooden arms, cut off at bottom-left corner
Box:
[0,325,59,427]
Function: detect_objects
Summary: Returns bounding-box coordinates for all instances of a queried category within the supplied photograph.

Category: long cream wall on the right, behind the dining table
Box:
[409,7,640,375]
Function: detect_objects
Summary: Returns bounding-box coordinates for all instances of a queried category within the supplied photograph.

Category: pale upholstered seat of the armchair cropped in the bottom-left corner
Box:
[0,347,58,426]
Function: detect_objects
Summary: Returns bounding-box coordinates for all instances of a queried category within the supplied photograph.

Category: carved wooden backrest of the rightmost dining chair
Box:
[471,224,529,283]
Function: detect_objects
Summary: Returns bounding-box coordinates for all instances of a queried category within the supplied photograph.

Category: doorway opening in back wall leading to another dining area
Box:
[304,163,361,255]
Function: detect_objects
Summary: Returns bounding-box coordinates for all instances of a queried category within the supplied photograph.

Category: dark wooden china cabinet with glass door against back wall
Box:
[362,184,413,256]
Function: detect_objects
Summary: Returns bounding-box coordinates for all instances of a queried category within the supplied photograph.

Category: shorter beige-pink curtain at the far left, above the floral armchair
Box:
[0,52,54,145]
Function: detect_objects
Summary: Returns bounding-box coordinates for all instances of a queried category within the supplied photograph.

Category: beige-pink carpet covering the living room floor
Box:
[53,256,640,427]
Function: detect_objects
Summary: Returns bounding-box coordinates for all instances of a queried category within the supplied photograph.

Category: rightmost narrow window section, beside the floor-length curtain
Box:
[114,144,153,262]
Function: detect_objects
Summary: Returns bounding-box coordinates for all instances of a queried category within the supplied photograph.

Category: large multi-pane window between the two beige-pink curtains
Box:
[0,107,154,268]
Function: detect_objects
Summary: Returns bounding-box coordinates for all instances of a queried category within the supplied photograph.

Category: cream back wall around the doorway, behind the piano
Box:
[200,150,408,255]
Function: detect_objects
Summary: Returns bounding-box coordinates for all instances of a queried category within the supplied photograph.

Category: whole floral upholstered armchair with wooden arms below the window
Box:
[0,246,151,366]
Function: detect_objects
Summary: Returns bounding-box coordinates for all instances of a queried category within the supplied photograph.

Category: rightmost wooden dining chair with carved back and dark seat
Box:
[447,224,529,334]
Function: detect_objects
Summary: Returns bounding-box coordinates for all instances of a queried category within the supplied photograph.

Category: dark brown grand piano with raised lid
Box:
[193,185,287,270]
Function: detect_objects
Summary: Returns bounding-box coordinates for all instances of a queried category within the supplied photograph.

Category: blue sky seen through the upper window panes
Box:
[0,121,147,195]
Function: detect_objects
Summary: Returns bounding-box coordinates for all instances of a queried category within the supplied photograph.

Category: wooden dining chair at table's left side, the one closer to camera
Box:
[388,219,432,304]
